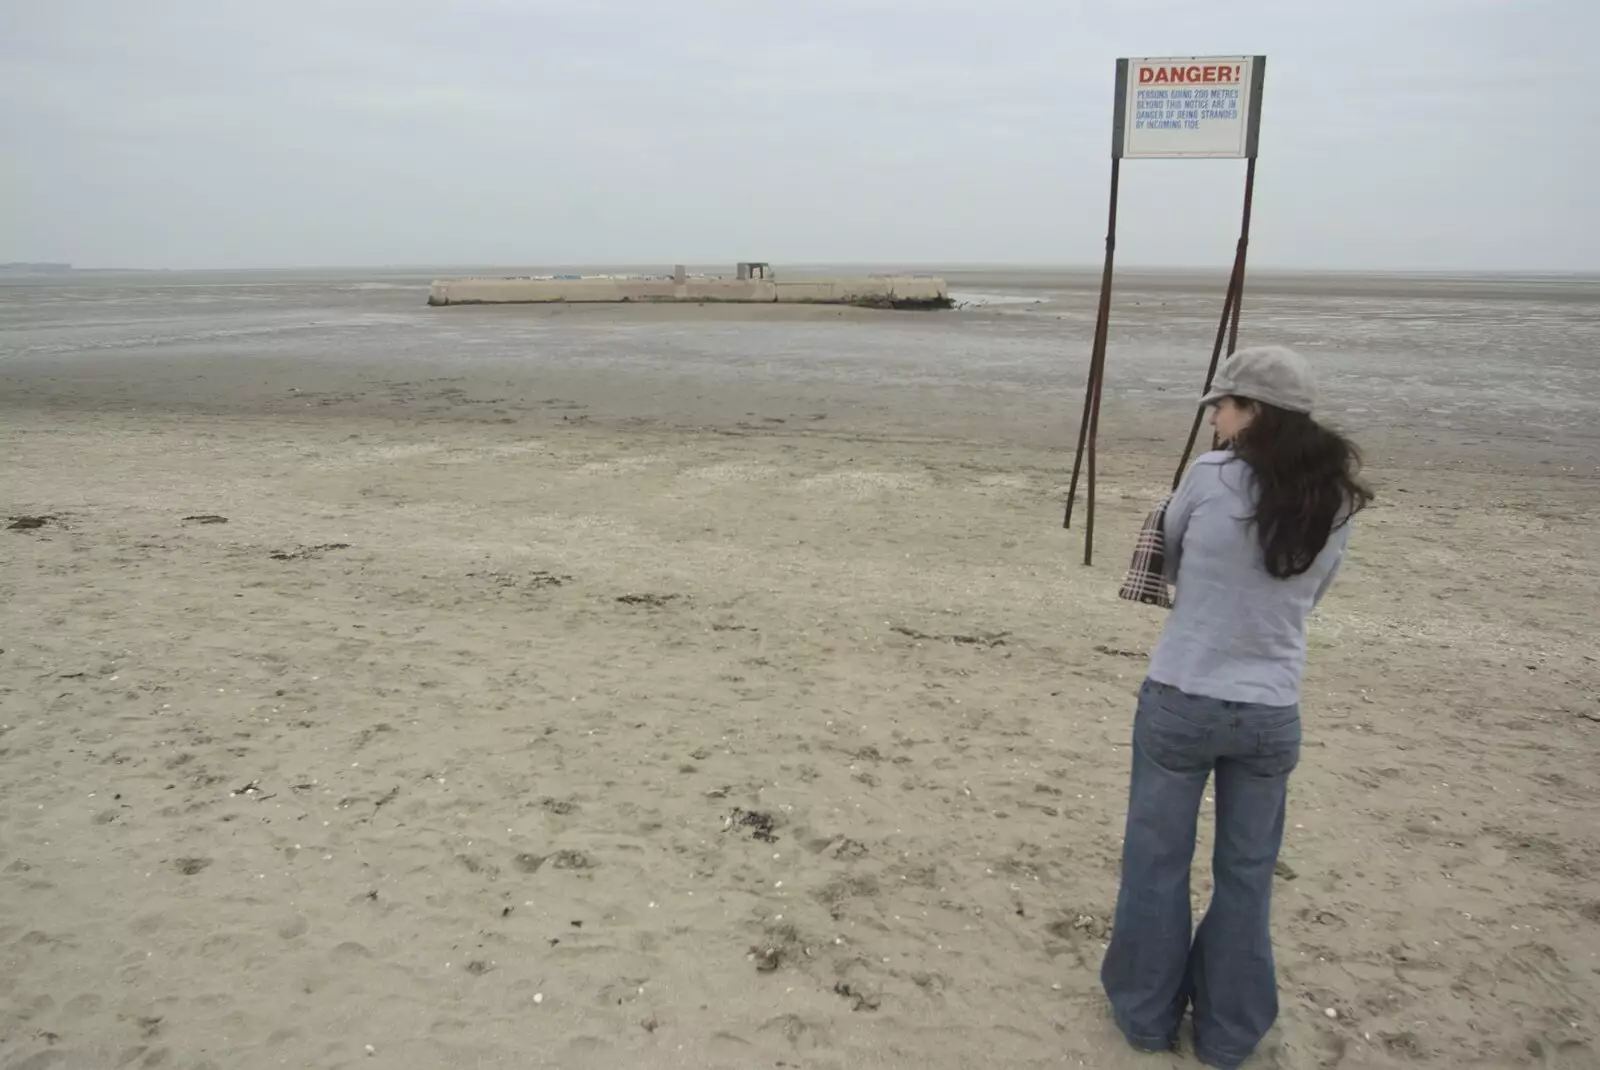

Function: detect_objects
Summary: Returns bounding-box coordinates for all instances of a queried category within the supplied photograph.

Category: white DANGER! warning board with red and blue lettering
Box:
[1112,56,1267,160]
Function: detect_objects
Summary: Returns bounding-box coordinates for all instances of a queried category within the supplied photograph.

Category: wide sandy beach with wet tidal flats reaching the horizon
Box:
[0,270,1600,1070]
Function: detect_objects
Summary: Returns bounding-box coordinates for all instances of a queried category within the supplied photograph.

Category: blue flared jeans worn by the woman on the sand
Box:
[1101,681,1301,1067]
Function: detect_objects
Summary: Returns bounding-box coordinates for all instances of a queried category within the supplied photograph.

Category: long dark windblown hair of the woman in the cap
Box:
[1234,398,1373,579]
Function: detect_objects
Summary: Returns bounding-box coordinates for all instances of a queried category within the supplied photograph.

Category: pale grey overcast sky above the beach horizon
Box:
[0,0,1600,270]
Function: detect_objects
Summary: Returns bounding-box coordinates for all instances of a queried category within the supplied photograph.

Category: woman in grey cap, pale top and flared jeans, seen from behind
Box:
[1101,347,1373,1067]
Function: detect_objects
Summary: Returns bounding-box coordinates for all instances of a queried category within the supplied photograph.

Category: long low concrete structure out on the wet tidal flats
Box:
[427,262,950,309]
